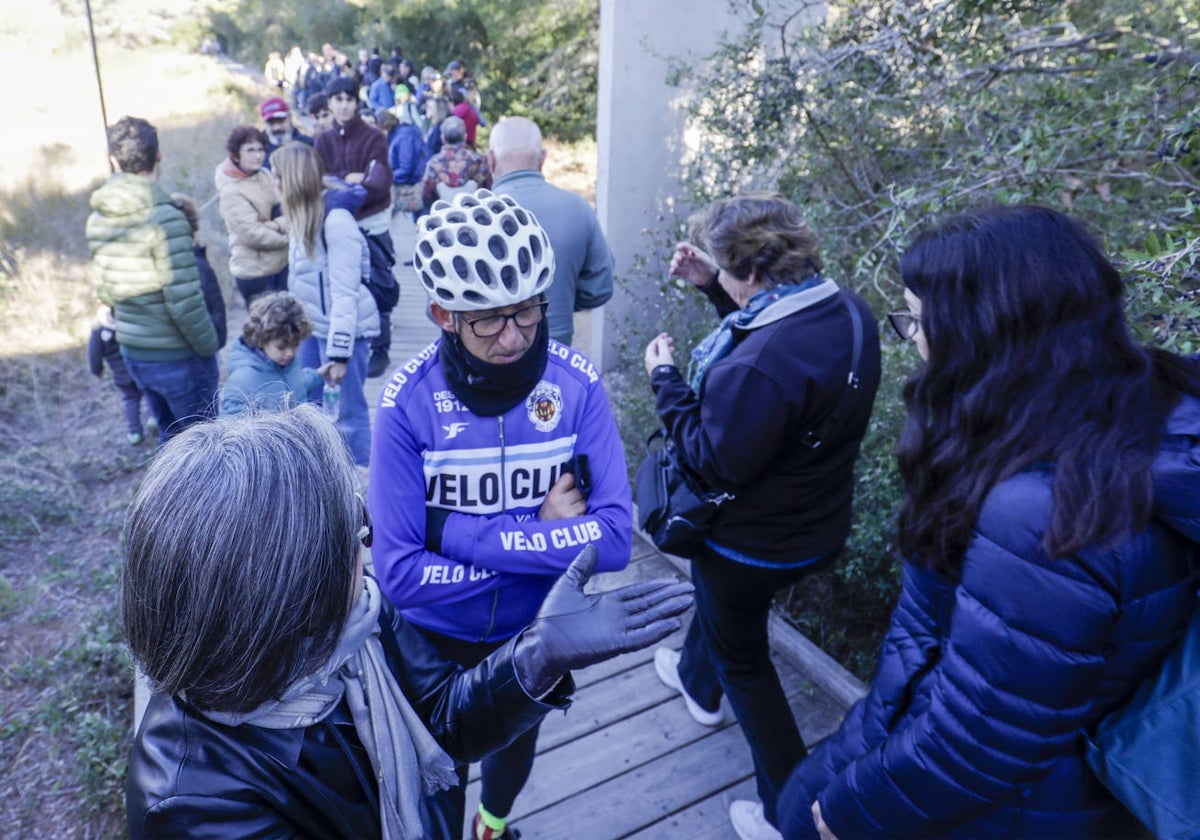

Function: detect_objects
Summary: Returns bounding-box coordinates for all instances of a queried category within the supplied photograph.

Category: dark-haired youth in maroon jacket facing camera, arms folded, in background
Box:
[317,77,400,377]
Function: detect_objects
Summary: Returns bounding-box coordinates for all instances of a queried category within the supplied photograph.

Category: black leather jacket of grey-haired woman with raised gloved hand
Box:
[126,605,574,839]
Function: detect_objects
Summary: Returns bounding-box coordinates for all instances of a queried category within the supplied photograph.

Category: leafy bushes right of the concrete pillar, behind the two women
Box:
[657,0,1200,676]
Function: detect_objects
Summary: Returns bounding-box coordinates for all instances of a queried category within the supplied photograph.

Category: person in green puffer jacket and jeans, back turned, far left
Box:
[86,116,220,443]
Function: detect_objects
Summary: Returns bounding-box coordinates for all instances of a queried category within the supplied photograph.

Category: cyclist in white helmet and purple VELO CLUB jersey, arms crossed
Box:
[370,190,632,838]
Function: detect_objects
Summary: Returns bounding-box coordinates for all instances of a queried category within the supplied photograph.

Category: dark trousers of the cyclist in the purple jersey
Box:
[416,628,541,826]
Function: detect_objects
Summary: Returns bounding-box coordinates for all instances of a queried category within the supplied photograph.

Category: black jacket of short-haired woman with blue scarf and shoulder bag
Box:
[650,283,880,563]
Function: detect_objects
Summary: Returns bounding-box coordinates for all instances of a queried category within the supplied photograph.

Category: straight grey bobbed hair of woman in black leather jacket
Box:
[121,406,362,712]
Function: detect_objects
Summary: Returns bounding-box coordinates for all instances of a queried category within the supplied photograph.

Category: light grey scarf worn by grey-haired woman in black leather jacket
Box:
[202,576,458,840]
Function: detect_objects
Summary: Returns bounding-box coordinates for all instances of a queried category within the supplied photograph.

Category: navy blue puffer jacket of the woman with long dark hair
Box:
[779,397,1200,840]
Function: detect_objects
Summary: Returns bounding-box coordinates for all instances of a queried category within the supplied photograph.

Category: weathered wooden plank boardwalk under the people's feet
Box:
[367,215,845,840]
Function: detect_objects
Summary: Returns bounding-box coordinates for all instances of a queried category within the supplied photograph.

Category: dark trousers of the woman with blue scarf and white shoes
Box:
[679,546,826,826]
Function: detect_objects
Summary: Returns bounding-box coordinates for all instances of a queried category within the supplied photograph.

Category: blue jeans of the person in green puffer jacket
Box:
[125,355,221,445]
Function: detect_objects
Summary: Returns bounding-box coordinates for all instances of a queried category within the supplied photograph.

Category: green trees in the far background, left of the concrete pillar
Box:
[210,0,600,140]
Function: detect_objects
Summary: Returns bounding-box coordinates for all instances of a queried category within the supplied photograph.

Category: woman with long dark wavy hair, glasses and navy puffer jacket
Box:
[779,206,1200,840]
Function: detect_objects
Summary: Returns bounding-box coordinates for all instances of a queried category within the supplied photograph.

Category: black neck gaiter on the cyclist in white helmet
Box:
[438,319,550,418]
